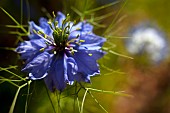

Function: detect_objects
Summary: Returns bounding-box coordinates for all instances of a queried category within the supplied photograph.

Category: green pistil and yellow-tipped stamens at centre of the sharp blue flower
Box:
[33,14,84,54]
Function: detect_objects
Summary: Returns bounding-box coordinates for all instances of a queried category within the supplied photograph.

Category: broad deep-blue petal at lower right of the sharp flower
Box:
[74,50,105,83]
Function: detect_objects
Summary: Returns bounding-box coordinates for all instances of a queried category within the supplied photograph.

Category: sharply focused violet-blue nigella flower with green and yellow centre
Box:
[16,12,106,91]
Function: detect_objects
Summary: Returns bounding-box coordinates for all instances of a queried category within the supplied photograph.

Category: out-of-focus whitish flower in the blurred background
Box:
[126,24,167,63]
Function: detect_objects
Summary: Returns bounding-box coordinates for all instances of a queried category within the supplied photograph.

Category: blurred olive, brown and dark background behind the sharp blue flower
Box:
[0,0,170,113]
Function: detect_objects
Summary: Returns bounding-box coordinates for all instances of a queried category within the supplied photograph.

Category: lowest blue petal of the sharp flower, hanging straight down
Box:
[44,55,68,91]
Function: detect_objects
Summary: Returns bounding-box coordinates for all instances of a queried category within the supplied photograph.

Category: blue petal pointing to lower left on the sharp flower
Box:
[22,52,53,80]
